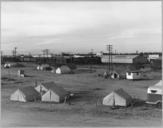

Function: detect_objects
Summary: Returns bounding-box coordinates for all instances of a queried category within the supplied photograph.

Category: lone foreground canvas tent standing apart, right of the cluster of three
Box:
[102,89,132,107]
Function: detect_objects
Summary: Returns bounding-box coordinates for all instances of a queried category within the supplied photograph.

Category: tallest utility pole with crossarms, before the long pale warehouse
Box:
[106,44,113,74]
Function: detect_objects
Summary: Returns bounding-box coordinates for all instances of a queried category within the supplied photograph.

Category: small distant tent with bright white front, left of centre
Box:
[56,65,71,74]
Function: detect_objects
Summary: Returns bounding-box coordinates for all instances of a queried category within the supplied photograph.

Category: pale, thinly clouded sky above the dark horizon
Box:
[1,1,162,54]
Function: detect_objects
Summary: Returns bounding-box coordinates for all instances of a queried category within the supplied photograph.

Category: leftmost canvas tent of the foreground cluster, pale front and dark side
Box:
[10,86,41,102]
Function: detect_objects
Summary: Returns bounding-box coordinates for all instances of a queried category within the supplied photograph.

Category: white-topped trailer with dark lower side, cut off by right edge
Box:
[146,80,163,104]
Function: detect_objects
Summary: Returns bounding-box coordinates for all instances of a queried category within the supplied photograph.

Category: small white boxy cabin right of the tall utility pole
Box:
[126,71,143,80]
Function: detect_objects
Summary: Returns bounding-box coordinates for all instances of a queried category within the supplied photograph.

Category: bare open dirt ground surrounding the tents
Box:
[1,64,162,126]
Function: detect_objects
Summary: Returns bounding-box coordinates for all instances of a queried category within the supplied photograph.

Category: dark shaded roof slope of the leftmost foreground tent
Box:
[19,86,40,97]
